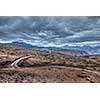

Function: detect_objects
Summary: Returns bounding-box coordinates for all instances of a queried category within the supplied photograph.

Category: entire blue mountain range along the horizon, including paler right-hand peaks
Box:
[0,42,100,56]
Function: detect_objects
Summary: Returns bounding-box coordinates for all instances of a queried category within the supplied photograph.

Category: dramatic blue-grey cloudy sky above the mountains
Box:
[0,16,100,47]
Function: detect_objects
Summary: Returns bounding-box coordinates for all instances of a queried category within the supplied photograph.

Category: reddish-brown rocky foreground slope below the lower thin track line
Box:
[0,66,100,83]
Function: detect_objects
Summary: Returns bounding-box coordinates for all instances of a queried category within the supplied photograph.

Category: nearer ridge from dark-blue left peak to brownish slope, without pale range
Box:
[0,42,88,56]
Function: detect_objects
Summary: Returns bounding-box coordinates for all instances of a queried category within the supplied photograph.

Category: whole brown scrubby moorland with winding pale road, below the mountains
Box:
[0,46,100,83]
